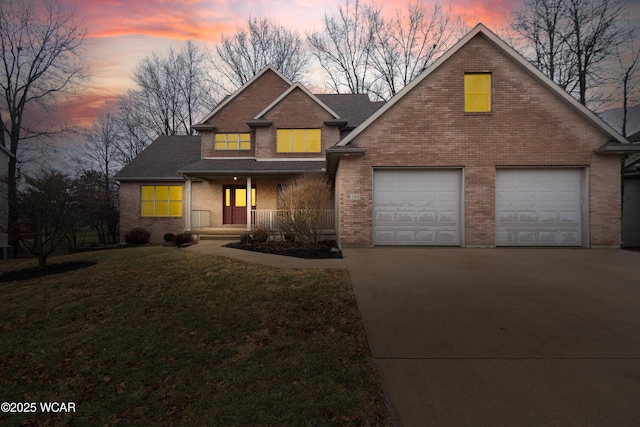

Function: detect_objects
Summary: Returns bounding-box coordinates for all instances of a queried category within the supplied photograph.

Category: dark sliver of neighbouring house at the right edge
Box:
[622,132,640,248]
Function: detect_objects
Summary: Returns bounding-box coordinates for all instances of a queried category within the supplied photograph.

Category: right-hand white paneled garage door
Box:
[496,169,584,246]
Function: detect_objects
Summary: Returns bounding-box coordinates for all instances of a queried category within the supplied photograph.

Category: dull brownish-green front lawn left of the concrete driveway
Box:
[0,247,389,426]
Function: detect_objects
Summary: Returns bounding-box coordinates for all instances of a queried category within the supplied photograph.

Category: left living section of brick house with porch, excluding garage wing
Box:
[115,67,382,241]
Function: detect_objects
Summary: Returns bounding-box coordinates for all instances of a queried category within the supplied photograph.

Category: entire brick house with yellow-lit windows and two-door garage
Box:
[116,24,637,247]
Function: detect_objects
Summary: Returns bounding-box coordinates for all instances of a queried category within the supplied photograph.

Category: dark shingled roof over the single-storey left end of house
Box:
[113,135,200,181]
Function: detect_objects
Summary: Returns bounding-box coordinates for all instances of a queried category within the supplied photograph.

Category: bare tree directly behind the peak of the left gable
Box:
[215,18,309,89]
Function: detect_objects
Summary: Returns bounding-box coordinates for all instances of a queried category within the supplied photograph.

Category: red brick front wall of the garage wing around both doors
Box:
[336,34,620,247]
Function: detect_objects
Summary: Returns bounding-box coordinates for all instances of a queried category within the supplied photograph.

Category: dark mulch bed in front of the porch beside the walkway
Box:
[225,240,342,259]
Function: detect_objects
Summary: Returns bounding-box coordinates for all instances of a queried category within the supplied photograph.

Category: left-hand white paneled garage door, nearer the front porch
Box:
[373,169,462,246]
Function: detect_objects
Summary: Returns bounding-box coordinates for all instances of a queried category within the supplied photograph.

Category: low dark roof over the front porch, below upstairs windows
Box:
[178,159,326,176]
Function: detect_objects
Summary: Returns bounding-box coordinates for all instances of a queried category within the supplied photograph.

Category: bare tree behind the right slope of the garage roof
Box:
[511,0,628,107]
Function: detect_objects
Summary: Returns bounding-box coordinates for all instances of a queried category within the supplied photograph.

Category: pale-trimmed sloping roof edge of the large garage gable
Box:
[332,24,628,150]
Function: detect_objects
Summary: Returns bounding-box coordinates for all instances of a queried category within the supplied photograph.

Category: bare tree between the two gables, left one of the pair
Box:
[307,0,383,97]
